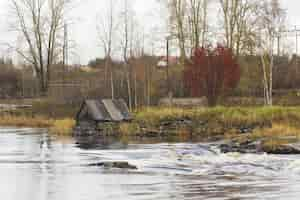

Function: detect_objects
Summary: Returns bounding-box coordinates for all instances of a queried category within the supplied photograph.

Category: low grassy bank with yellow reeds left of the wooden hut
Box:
[0,99,79,135]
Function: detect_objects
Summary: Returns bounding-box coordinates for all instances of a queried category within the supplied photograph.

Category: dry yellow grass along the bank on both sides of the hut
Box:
[0,106,300,139]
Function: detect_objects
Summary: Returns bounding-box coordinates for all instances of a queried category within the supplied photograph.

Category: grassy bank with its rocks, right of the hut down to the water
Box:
[120,107,300,148]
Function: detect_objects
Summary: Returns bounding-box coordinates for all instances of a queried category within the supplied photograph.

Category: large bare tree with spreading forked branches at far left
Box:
[10,0,71,93]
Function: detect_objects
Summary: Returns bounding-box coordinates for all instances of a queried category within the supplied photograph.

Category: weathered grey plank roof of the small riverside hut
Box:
[77,99,132,122]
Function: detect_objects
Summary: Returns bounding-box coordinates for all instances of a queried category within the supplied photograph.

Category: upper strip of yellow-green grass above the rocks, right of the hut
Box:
[122,107,300,132]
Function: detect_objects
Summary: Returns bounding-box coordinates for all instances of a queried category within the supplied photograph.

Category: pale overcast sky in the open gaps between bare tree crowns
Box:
[0,0,300,64]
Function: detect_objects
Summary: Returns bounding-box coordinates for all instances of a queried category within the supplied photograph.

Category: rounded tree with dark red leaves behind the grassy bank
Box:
[184,46,240,106]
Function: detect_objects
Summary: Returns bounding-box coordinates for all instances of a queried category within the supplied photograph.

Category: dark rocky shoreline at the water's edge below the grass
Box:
[74,118,300,154]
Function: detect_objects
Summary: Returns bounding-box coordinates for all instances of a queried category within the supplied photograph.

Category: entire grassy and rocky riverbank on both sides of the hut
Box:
[0,105,300,152]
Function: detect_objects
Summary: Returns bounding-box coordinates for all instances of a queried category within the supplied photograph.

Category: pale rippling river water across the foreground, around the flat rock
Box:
[0,128,300,200]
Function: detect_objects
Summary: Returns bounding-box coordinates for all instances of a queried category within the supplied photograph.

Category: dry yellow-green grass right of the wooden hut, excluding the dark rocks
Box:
[126,106,300,140]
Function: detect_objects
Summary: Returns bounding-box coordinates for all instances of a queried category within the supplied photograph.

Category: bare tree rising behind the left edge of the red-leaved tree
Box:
[160,0,210,59]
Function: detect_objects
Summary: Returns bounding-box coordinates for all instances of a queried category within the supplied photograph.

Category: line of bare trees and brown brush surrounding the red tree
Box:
[0,0,300,109]
